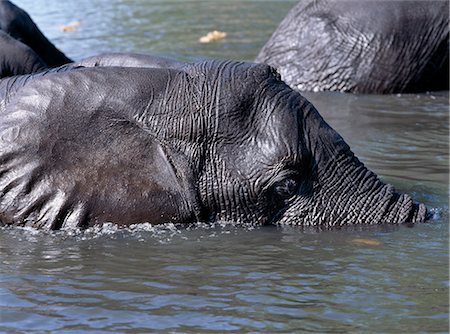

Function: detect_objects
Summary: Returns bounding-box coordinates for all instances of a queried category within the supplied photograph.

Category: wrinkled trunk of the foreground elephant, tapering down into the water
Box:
[281,101,426,226]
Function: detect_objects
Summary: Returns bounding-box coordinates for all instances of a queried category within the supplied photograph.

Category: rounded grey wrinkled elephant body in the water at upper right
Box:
[255,0,449,94]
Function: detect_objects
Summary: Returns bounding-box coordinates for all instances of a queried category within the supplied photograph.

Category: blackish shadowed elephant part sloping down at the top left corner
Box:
[0,0,72,69]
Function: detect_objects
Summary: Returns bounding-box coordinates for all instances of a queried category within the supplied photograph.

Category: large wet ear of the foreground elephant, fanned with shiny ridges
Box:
[0,69,200,229]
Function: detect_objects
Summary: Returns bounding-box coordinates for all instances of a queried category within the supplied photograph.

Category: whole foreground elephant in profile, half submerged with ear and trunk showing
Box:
[0,61,426,229]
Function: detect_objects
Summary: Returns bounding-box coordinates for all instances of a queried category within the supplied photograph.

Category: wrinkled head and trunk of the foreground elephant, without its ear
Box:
[140,61,426,226]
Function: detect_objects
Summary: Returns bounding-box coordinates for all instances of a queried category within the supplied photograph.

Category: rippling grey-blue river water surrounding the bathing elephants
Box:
[0,0,449,333]
